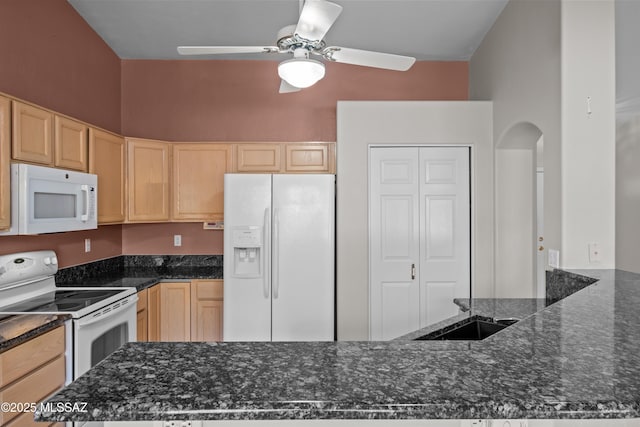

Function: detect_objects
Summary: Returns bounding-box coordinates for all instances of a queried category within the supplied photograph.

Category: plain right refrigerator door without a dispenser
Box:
[270,174,335,341]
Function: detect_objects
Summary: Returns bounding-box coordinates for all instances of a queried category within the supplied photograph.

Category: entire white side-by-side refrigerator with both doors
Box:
[223,174,335,341]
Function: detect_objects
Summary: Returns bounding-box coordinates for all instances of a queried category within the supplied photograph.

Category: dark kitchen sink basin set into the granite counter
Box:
[415,316,518,341]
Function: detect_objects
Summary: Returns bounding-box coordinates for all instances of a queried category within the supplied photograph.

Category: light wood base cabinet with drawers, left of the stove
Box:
[0,326,65,427]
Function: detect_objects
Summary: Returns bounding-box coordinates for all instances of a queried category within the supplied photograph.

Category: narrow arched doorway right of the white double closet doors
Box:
[495,122,546,298]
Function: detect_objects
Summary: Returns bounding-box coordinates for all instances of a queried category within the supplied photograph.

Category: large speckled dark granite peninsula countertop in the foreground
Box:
[36,271,640,421]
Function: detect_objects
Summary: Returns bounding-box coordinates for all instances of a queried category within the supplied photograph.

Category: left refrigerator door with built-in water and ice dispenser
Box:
[223,174,271,341]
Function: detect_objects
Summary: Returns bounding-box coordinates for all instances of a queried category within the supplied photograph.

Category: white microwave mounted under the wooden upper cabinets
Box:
[0,163,98,236]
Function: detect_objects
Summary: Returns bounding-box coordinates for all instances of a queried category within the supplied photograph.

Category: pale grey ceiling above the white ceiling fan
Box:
[63,0,508,61]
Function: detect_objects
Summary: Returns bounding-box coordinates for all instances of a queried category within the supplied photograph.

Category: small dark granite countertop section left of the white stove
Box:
[0,314,71,353]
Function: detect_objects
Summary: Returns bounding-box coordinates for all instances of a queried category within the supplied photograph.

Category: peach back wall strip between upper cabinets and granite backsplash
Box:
[122,222,224,255]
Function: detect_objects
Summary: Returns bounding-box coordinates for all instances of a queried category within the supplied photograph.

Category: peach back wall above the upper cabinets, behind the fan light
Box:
[122,60,468,141]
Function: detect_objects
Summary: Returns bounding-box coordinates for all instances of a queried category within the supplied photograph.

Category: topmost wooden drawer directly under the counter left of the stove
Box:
[0,326,64,390]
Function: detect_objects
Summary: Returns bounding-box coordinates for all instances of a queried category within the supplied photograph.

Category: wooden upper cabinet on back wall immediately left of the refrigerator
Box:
[171,143,232,221]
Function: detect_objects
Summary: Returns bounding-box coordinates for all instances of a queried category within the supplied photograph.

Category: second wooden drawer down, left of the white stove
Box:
[0,356,65,425]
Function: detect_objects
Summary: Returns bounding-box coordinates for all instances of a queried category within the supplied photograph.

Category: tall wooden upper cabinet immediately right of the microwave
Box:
[89,128,125,224]
